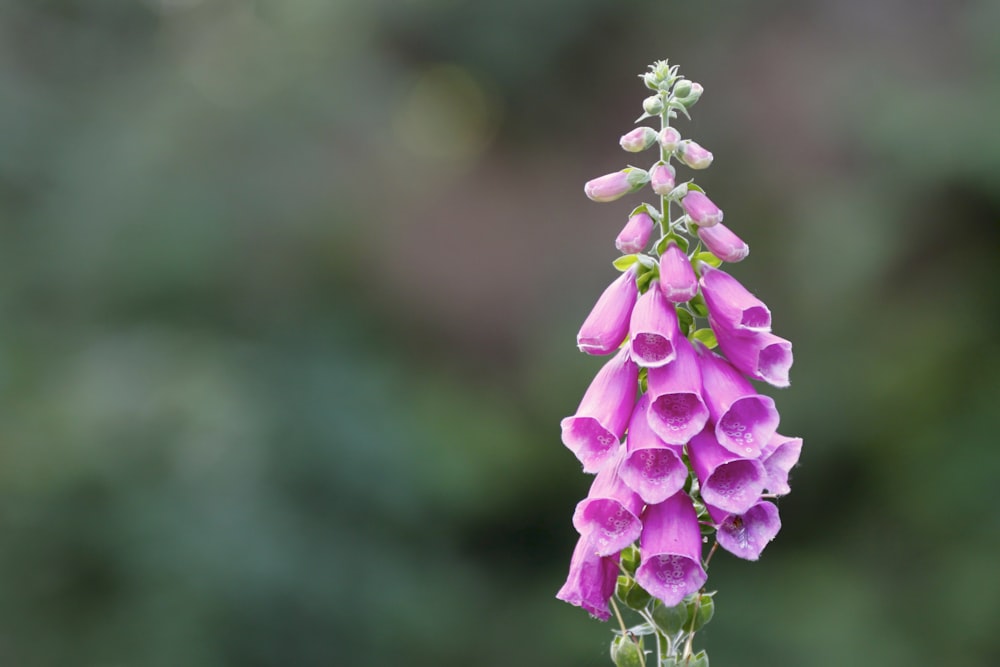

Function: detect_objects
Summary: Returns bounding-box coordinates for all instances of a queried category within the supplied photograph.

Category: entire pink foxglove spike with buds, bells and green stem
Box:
[557,62,802,666]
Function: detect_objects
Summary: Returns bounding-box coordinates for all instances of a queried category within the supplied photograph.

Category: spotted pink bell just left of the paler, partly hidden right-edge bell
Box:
[688,426,767,514]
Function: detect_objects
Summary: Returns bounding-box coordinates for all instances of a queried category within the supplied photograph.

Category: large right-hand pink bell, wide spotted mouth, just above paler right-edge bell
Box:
[698,348,779,458]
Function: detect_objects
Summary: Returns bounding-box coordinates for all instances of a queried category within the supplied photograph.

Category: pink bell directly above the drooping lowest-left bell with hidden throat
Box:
[573,445,643,556]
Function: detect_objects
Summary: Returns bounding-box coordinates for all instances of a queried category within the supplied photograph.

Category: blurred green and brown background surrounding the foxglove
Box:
[0,0,1000,667]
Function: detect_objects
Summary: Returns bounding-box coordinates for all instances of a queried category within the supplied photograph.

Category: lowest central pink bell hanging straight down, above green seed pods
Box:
[635,491,708,607]
